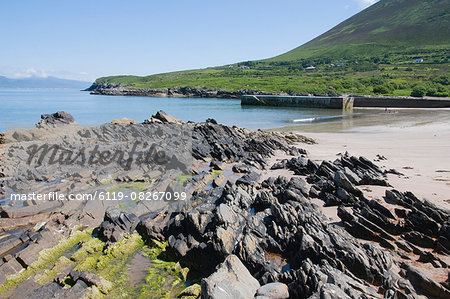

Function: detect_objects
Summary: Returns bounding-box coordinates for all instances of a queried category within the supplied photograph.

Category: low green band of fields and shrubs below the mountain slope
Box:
[96,49,450,97]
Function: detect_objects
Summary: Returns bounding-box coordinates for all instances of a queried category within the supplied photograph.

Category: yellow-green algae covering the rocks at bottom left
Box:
[0,230,193,298]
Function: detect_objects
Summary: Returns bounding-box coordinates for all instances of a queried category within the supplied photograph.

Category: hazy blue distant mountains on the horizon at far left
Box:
[0,76,91,89]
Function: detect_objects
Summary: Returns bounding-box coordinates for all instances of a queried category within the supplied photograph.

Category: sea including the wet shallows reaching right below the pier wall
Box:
[0,89,442,132]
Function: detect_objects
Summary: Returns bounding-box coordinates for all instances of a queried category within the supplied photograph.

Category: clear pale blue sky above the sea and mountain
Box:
[0,0,377,81]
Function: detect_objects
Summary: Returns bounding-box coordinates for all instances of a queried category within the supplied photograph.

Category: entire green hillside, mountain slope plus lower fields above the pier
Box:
[92,0,450,96]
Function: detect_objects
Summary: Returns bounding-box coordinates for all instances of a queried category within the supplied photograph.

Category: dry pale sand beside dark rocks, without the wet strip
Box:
[301,120,450,209]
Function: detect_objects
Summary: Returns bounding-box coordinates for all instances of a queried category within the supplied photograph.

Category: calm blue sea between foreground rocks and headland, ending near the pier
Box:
[0,89,352,131]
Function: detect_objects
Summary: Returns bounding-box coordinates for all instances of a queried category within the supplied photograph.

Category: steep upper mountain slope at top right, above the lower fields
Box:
[269,0,450,61]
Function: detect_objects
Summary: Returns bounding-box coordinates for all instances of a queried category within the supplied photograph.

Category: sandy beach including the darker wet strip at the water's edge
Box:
[270,109,450,210]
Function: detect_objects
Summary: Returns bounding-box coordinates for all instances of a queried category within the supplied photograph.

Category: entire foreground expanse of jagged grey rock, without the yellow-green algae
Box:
[0,111,450,298]
